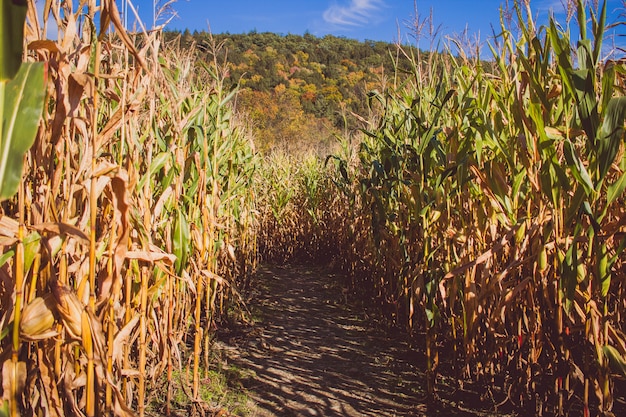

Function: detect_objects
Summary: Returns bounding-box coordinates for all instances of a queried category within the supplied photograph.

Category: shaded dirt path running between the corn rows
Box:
[214,266,508,417]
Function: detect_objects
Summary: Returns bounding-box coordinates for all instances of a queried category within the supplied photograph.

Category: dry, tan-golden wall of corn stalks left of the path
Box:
[0,0,258,417]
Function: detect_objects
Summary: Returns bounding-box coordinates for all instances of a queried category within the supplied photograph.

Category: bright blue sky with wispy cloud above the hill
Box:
[118,0,626,52]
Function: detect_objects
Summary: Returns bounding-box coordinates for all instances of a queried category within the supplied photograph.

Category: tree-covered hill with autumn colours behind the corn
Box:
[166,31,416,150]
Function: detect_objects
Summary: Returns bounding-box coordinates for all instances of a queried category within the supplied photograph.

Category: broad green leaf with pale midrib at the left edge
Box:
[0,63,46,200]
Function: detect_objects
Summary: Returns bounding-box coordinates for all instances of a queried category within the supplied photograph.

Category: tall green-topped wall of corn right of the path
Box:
[316,1,626,416]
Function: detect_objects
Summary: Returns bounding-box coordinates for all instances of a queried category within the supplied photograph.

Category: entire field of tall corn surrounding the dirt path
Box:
[0,0,626,417]
